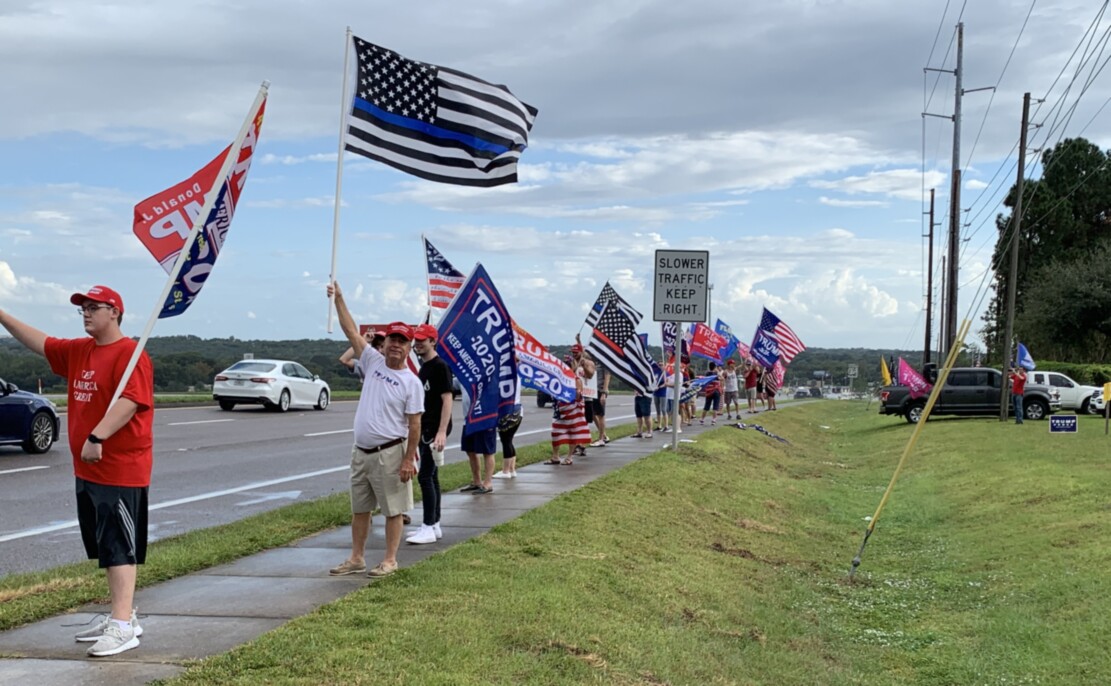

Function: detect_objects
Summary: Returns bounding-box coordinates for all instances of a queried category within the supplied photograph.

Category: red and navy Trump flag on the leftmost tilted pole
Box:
[132,98,267,319]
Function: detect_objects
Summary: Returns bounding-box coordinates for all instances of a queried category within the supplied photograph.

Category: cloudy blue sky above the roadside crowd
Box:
[0,0,1111,349]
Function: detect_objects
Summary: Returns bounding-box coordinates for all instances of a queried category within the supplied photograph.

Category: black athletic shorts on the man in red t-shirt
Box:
[77,478,148,569]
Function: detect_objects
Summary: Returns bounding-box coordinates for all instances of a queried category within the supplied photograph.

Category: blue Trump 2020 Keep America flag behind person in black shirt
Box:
[436,265,518,435]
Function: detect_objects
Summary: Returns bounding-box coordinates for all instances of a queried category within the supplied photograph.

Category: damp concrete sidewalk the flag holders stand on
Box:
[0,421,721,686]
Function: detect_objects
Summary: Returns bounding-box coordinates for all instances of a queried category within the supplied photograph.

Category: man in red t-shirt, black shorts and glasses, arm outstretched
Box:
[0,286,154,657]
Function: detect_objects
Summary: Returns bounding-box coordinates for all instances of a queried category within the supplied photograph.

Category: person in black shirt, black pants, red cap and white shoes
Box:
[406,324,452,545]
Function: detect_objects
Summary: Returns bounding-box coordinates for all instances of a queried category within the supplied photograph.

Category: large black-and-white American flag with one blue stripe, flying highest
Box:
[343,37,537,186]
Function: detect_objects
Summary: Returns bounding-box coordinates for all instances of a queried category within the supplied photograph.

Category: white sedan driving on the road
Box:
[212,359,332,412]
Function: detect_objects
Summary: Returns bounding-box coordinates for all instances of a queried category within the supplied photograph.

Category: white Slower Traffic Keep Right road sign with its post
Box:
[652,250,710,450]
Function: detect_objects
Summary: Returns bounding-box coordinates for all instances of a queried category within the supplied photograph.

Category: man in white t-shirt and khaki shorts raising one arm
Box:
[327,282,424,578]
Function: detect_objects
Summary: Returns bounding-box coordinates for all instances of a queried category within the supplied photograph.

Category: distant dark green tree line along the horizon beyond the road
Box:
[0,336,922,394]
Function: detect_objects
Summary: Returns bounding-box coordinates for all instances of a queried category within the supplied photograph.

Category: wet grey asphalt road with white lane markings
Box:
[0,396,633,576]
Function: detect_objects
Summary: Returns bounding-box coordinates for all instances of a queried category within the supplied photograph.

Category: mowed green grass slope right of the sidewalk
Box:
[152,401,1111,685]
